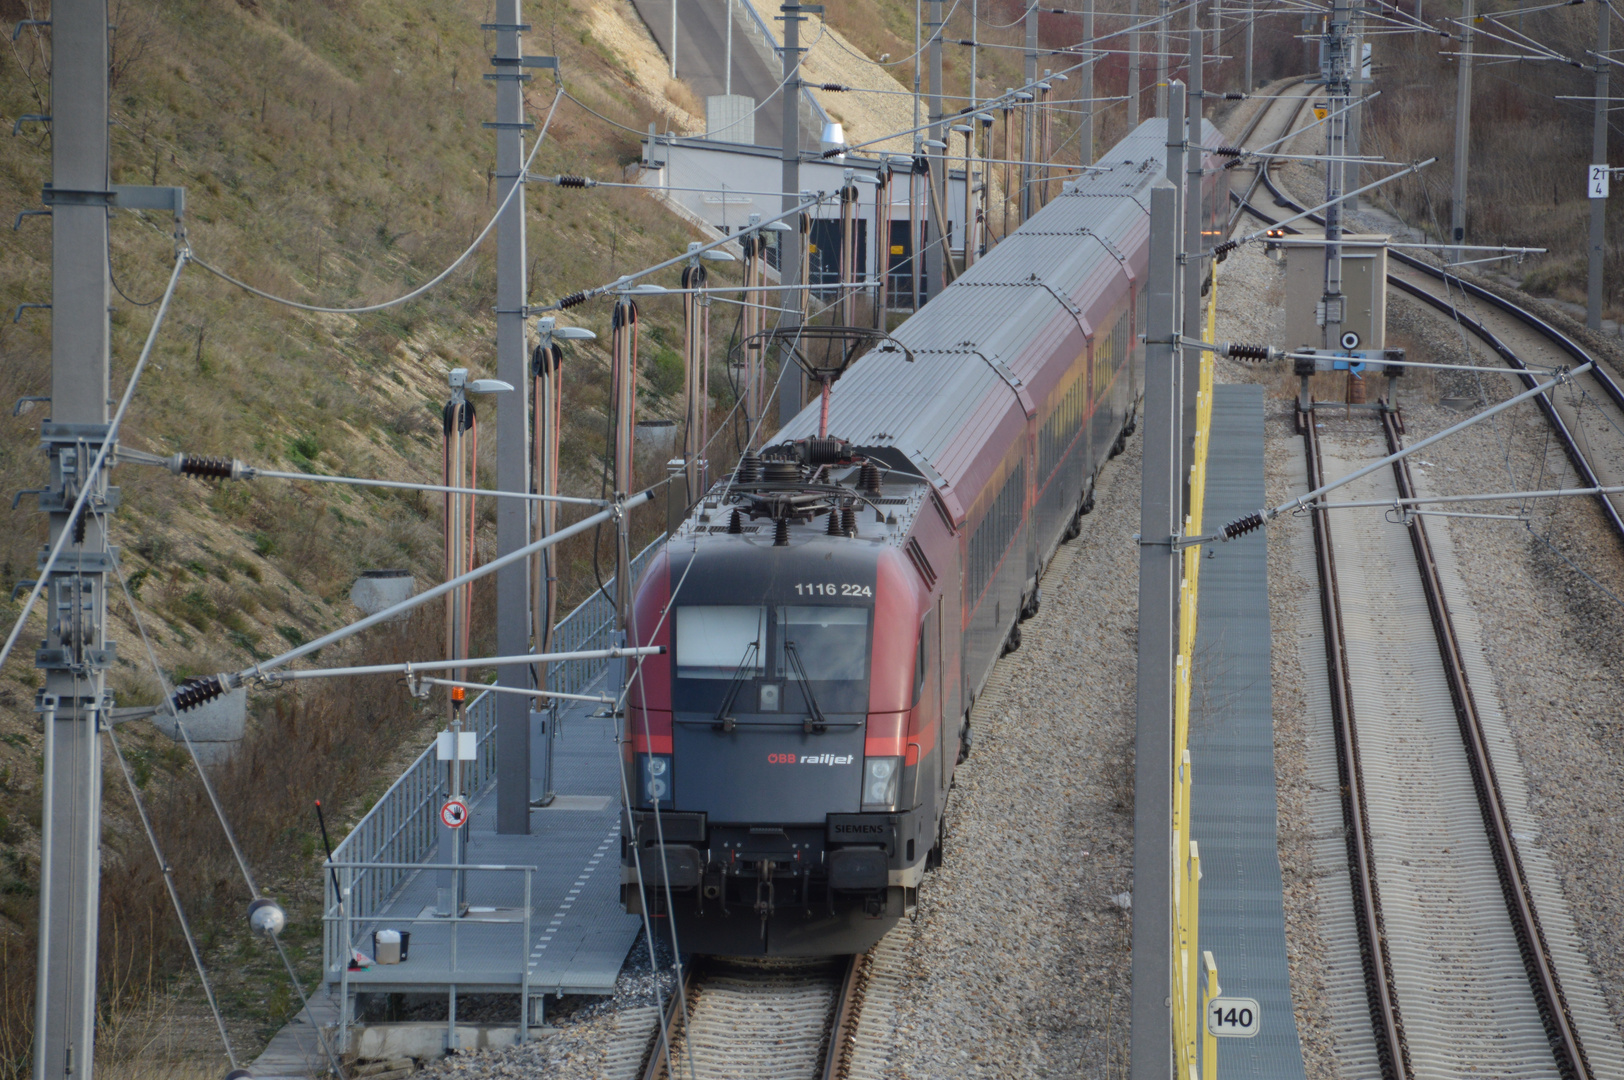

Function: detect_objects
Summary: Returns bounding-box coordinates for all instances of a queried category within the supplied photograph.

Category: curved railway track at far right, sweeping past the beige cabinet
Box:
[1231,93,1624,542]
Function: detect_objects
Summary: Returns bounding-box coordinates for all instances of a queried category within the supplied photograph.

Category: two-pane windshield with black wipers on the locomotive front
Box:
[672,604,870,715]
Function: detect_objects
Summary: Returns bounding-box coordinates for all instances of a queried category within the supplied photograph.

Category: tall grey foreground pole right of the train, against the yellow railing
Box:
[1129,180,1184,1080]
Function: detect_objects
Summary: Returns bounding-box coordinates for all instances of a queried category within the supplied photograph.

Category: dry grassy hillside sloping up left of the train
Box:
[0,0,747,1077]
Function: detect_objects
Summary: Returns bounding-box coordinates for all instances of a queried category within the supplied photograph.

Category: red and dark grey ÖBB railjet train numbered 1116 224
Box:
[622,120,1223,955]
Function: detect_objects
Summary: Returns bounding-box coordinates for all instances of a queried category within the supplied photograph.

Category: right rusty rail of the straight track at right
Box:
[1383,413,1595,1080]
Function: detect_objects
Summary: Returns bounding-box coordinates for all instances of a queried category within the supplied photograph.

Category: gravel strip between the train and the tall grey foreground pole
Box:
[885,437,1142,1080]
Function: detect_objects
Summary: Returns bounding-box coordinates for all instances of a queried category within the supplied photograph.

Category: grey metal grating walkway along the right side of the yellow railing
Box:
[1190,385,1304,1080]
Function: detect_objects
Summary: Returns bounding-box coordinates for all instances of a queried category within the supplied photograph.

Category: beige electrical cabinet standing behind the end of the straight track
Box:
[1272,234,1387,349]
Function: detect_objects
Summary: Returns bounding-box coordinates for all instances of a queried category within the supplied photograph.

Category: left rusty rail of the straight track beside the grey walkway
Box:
[1298,411,1415,1080]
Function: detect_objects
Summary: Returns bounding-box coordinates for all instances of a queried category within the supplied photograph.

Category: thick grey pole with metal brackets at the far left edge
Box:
[34,0,114,1080]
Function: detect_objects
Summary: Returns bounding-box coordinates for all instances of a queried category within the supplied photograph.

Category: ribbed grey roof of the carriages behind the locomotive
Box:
[771,120,1218,513]
